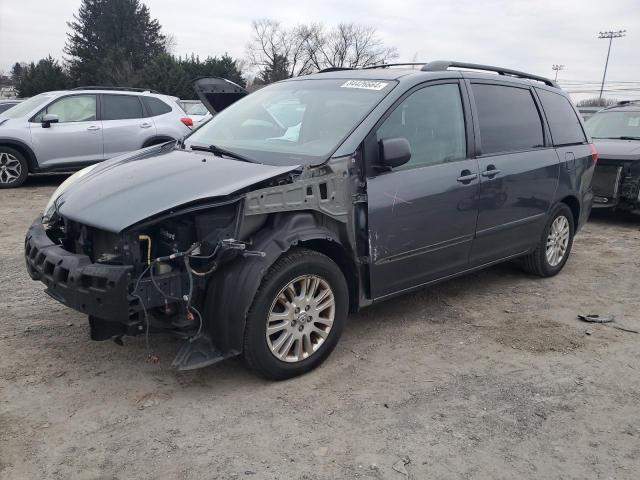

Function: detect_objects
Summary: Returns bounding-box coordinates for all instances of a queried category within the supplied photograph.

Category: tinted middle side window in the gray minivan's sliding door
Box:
[471,83,544,155]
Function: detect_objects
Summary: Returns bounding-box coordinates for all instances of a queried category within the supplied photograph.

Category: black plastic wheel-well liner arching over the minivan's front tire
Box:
[204,212,339,356]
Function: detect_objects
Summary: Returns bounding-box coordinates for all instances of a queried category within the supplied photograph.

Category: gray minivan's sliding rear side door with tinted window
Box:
[464,82,560,266]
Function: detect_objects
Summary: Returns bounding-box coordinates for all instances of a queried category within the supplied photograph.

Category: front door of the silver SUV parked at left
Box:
[29,94,104,168]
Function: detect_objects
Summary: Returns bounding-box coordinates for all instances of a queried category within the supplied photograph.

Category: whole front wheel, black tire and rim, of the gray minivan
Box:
[244,248,349,380]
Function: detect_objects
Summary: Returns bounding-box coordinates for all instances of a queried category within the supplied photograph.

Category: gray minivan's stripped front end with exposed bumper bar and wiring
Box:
[25,199,262,368]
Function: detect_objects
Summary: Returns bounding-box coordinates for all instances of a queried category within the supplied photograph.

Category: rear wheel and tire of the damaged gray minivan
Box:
[521,203,575,277]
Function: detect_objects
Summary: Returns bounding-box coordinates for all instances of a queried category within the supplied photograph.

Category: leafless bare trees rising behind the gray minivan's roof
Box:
[247,19,398,83]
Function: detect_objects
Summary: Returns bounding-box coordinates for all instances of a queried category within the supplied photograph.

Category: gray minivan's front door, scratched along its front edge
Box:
[367,82,479,299]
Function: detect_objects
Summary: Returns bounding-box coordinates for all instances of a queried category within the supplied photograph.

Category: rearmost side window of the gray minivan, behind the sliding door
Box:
[536,89,587,146]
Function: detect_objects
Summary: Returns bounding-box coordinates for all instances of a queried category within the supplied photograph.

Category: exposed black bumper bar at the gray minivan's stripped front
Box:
[25,218,133,323]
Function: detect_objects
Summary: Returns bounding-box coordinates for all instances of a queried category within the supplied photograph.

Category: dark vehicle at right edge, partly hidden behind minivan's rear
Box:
[585,100,640,214]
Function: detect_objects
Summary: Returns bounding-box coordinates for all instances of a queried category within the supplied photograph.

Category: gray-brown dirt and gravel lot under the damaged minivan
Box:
[0,177,640,479]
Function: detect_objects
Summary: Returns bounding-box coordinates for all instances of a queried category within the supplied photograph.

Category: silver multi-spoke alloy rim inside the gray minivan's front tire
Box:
[266,275,336,363]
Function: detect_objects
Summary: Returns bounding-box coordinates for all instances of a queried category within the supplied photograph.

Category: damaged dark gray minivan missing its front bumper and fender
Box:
[25,62,597,379]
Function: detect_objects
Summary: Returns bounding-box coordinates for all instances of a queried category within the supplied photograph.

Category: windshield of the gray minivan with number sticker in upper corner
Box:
[187,79,395,165]
